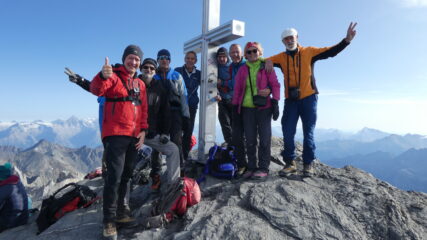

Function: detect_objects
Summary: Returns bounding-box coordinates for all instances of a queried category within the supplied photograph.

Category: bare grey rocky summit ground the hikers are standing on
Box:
[0,139,427,240]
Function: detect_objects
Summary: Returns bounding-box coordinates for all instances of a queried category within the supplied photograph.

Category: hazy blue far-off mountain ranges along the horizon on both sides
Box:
[0,117,427,192]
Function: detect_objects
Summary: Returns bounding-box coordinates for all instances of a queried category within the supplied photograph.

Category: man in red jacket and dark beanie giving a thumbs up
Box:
[90,45,148,239]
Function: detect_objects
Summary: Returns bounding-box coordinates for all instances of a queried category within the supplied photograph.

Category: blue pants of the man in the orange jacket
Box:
[282,94,317,164]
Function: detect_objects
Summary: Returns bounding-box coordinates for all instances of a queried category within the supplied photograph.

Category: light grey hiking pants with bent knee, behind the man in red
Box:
[144,135,180,183]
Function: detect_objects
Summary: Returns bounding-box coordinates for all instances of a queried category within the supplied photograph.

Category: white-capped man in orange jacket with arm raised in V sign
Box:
[266,23,357,176]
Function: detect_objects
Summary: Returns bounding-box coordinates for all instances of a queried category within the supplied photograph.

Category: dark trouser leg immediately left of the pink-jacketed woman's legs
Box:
[232,107,248,168]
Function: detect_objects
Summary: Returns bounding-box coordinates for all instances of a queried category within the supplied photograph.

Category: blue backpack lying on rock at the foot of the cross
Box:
[204,144,237,179]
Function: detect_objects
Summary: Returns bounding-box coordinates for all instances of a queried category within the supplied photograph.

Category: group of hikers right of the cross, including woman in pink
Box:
[211,23,356,179]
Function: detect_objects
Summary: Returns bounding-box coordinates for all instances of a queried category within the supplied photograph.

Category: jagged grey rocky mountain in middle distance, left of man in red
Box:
[0,140,103,205]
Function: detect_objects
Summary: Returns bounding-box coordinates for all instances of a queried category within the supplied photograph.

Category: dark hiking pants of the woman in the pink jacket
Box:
[241,107,272,173]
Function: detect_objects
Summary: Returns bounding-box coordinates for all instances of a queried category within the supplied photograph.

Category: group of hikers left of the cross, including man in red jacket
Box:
[67,45,201,239]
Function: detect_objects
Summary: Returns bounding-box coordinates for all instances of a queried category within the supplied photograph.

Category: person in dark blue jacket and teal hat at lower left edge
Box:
[0,163,28,232]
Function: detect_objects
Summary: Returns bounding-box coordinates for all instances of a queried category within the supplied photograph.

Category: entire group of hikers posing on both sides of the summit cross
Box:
[66,23,356,239]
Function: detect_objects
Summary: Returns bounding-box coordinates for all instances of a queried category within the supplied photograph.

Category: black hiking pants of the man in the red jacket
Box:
[103,136,138,223]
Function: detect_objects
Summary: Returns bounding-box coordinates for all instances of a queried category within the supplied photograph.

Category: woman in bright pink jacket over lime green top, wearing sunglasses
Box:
[232,42,280,179]
